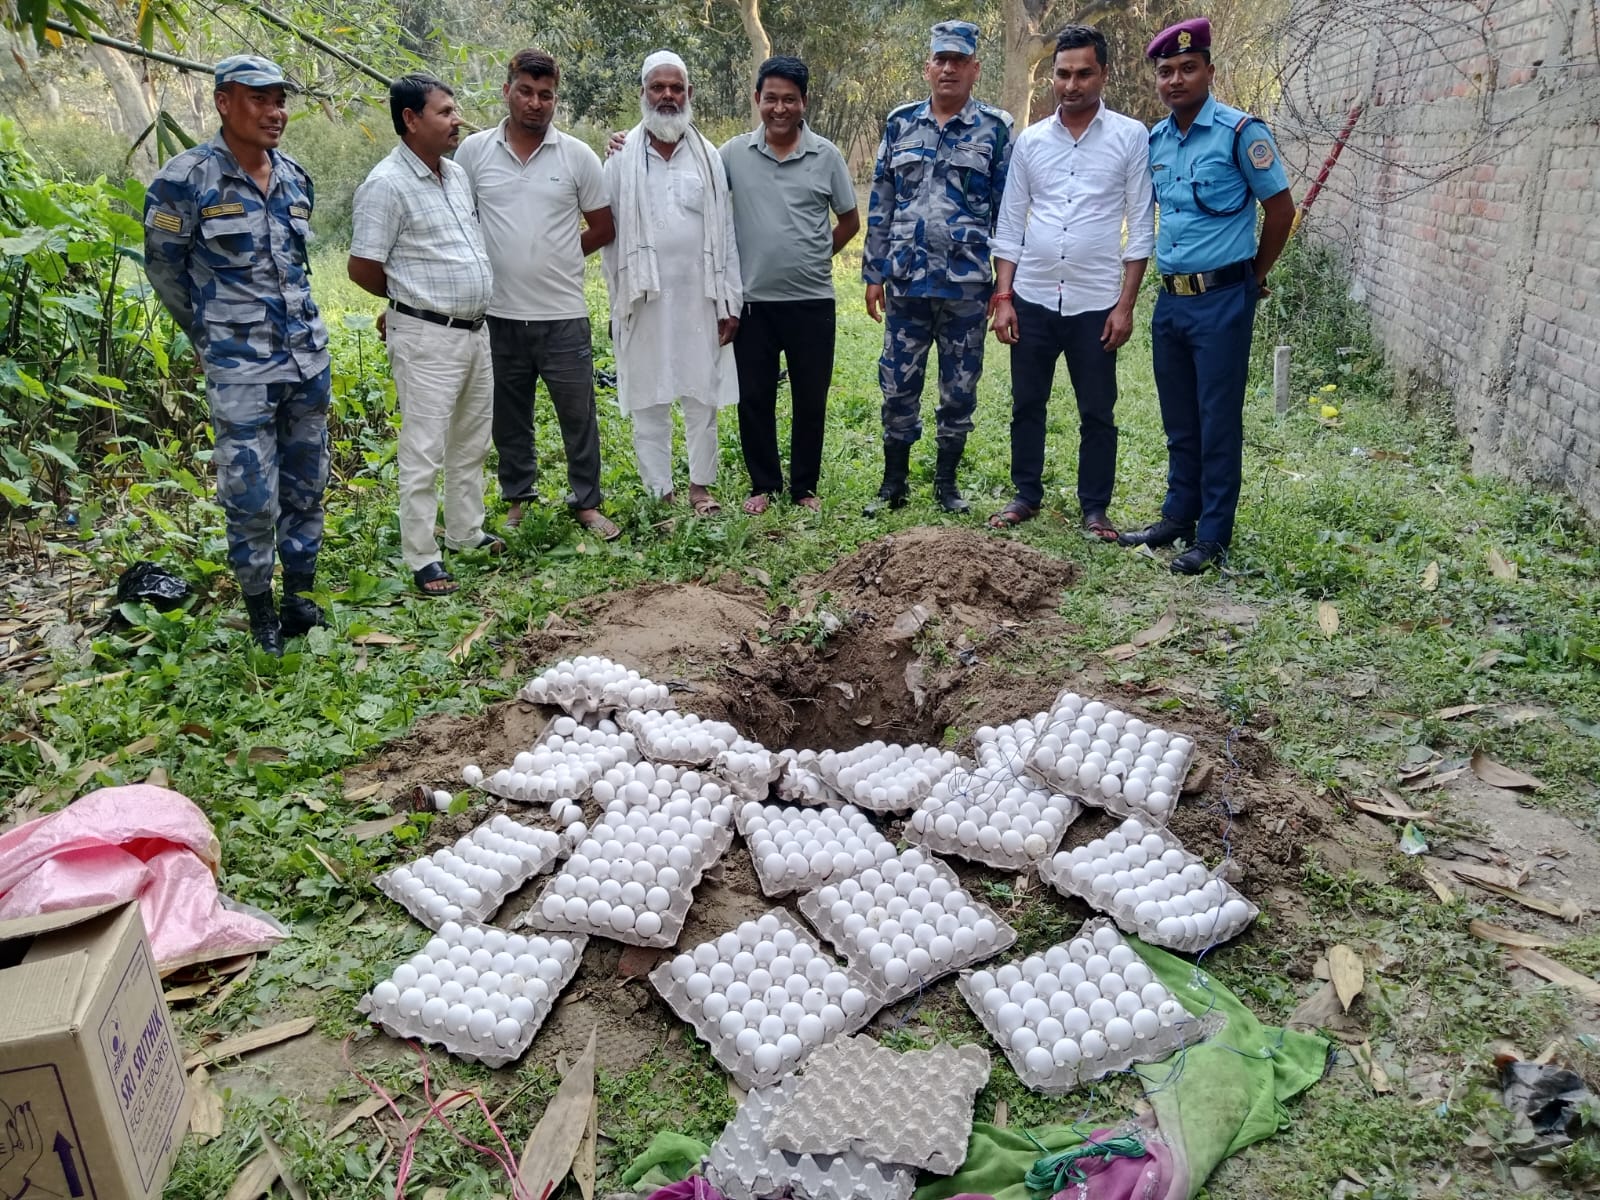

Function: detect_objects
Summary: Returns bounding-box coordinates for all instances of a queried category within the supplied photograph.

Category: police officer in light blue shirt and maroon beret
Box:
[1120,18,1294,574]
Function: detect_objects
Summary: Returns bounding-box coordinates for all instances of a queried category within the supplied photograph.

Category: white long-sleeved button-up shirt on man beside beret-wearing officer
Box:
[989,104,1155,317]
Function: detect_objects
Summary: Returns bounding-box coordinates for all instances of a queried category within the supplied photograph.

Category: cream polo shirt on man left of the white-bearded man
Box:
[456,117,605,322]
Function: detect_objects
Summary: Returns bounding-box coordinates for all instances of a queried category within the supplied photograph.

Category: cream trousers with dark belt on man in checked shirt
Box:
[387,309,494,571]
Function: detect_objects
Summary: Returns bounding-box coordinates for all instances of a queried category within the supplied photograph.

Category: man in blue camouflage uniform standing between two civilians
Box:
[861,21,1011,515]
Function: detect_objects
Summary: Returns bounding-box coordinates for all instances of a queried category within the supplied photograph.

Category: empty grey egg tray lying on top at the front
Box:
[766,1035,989,1174]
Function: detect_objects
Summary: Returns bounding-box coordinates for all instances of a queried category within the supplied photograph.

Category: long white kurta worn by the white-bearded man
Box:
[613,143,739,413]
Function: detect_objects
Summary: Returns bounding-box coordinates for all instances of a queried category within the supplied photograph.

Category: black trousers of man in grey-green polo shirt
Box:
[733,299,834,501]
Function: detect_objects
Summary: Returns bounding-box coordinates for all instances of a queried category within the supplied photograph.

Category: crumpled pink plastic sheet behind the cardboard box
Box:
[0,784,285,974]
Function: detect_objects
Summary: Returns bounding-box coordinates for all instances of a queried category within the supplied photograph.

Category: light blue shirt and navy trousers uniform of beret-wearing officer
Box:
[1150,96,1290,546]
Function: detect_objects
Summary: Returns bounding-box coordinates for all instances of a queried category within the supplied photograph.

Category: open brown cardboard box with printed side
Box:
[0,901,189,1200]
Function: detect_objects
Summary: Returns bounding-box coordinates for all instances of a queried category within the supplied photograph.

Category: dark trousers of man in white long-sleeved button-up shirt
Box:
[1011,296,1117,514]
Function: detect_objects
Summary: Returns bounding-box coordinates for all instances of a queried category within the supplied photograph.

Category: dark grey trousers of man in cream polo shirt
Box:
[490,317,600,509]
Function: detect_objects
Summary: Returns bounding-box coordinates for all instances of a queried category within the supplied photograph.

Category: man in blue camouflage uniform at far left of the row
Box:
[144,54,328,654]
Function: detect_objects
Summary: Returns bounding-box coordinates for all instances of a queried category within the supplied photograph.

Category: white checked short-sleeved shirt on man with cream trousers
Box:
[350,142,494,320]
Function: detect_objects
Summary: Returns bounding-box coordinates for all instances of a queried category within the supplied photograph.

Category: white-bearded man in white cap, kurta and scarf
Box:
[602,50,742,517]
